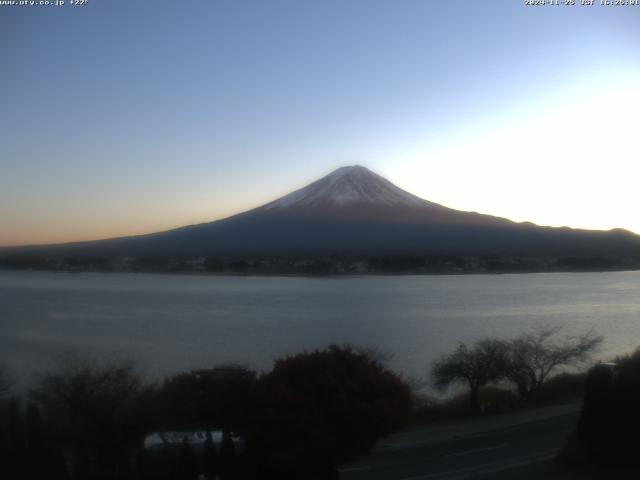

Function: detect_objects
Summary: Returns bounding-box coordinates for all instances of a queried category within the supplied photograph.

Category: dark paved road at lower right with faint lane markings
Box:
[340,412,578,480]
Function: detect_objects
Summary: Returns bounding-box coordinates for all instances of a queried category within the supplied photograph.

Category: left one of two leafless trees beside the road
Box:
[431,339,508,413]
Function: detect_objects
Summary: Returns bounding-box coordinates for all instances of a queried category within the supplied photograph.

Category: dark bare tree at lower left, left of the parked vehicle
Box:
[31,362,153,478]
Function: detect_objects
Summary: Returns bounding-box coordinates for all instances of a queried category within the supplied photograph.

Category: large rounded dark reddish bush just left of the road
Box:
[255,345,412,478]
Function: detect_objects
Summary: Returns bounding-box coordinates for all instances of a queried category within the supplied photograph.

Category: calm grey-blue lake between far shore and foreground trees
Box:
[0,271,640,386]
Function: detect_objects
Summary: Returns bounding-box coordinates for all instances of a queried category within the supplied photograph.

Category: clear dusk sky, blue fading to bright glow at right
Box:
[0,0,640,245]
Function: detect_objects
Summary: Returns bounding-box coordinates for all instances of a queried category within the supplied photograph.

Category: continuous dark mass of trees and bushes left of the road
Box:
[0,346,412,480]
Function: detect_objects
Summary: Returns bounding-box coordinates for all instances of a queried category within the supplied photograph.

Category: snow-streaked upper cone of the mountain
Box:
[263,165,445,210]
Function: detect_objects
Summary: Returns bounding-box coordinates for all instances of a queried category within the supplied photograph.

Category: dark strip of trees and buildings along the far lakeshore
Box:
[0,254,640,275]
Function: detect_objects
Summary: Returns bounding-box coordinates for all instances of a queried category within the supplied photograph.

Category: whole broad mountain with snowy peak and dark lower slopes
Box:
[0,166,640,257]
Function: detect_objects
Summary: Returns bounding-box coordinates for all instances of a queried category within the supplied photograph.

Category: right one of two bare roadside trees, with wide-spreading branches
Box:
[506,327,602,399]
